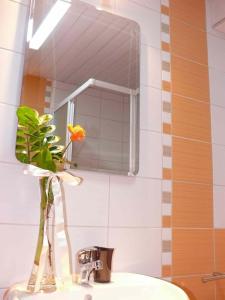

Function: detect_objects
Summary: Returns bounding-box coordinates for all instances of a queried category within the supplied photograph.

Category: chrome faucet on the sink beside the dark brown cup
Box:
[77,247,103,285]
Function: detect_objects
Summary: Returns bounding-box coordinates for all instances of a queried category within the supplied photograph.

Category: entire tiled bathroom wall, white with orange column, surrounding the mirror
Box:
[0,0,225,300]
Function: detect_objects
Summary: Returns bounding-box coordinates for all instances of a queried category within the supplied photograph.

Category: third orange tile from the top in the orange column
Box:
[171,55,209,102]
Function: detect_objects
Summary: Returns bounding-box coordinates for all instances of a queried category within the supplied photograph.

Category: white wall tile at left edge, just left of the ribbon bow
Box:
[0,163,40,224]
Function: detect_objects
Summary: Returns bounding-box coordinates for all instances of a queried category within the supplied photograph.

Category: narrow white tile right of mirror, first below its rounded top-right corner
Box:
[141,45,162,89]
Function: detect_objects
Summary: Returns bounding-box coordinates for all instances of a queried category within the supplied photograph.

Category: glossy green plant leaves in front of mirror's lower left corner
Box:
[16,106,65,172]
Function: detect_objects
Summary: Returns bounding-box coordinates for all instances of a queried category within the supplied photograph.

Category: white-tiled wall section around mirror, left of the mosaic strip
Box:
[0,0,162,291]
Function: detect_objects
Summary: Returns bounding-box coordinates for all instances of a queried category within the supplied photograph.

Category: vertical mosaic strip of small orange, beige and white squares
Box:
[161,0,172,280]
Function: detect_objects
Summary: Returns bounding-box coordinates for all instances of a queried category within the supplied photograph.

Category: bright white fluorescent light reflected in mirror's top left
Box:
[29,0,71,50]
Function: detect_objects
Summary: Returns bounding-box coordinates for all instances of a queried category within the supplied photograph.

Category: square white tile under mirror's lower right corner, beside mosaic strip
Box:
[109,176,161,227]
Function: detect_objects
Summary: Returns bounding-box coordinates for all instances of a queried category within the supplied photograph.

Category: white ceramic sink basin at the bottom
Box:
[4,273,189,300]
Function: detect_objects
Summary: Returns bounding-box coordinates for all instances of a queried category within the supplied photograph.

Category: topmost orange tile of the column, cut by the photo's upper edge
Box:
[170,0,206,30]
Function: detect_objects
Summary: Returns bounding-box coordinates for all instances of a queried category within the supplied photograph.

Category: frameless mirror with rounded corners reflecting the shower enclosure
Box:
[18,0,140,175]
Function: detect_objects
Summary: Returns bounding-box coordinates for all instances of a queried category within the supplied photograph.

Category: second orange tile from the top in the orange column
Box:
[171,18,208,65]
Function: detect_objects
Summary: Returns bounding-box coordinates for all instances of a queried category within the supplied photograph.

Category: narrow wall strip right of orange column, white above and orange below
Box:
[206,0,225,300]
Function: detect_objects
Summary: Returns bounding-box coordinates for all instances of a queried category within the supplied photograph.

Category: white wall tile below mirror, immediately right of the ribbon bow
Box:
[64,171,109,226]
